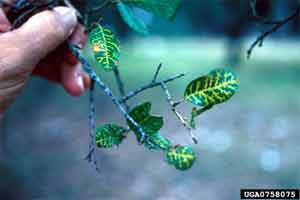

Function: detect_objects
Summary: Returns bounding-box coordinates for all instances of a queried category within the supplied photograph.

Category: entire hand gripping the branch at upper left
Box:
[0,7,90,115]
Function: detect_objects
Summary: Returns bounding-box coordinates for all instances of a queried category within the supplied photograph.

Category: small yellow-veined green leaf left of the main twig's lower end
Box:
[96,124,126,148]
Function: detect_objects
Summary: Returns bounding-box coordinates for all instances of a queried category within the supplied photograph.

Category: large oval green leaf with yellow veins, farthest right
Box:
[184,69,239,108]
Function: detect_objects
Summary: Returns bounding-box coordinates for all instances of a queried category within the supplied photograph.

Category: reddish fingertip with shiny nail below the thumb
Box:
[61,63,85,96]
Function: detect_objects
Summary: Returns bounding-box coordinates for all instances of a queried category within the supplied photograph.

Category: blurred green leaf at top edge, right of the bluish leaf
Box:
[122,0,182,20]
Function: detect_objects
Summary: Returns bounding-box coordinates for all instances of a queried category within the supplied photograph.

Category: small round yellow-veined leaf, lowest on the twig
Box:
[167,146,196,170]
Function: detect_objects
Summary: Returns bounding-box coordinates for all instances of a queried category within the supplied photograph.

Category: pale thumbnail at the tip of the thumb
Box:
[53,6,77,35]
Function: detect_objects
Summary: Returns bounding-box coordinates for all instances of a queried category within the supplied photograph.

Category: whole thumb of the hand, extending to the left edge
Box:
[0,7,77,114]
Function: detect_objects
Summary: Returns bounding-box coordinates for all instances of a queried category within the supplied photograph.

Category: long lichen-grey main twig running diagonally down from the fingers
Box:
[68,42,148,143]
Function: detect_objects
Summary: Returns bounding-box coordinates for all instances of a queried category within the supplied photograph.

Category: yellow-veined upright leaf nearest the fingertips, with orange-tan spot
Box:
[88,24,120,71]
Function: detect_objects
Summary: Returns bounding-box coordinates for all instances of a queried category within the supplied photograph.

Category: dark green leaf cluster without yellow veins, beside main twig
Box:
[127,102,163,145]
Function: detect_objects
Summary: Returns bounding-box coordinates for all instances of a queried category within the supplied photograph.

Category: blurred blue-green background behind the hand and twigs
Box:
[0,0,300,200]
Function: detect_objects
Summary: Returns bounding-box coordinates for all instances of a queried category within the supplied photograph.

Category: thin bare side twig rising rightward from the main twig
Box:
[119,73,185,103]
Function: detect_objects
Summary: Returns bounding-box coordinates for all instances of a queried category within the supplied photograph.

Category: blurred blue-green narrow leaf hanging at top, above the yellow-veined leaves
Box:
[117,2,149,35]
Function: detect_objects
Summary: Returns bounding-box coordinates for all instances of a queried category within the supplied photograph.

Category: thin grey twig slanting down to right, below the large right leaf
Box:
[161,82,198,144]
